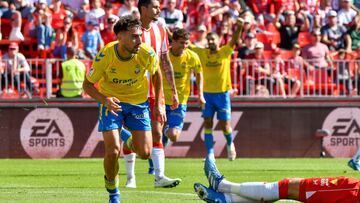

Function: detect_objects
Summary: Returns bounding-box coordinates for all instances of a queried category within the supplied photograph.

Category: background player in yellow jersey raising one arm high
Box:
[192,18,243,160]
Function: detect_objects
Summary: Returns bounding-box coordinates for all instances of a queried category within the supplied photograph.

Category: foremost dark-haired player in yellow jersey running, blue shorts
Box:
[83,16,165,203]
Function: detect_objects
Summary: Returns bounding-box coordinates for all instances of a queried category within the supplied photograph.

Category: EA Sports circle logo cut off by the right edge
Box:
[322,108,360,157]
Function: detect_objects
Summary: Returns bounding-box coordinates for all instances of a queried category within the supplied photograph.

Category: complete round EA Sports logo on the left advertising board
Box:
[20,108,74,158]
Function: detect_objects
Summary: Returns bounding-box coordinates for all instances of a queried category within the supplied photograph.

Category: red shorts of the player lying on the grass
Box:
[299,177,360,203]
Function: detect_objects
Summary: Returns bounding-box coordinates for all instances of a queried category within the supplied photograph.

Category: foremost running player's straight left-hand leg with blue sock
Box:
[103,129,120,202]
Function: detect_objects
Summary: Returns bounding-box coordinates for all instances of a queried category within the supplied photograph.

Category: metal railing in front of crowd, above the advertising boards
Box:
[0,59,360,99]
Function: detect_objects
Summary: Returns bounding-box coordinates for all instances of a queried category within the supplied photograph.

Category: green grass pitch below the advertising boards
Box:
[0,158,360,203]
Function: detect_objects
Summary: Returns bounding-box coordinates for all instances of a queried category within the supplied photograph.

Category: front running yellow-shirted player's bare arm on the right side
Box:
[151,68,166,123]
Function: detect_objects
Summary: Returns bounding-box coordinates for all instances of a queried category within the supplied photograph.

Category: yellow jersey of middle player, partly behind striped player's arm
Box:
[163,49,202,105]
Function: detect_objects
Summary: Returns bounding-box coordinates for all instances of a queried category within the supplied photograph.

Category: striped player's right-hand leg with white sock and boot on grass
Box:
[151,121,181,187]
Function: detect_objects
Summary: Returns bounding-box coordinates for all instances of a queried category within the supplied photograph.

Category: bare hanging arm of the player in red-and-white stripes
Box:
[160,52,179,109]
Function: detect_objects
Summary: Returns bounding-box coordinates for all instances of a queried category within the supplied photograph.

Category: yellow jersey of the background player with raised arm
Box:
[191,44,234,93]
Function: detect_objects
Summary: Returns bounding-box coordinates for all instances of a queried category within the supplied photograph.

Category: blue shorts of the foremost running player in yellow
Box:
[98,102,151,132]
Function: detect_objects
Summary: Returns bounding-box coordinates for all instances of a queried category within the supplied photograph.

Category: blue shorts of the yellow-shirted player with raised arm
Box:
[202,91,231,121]
